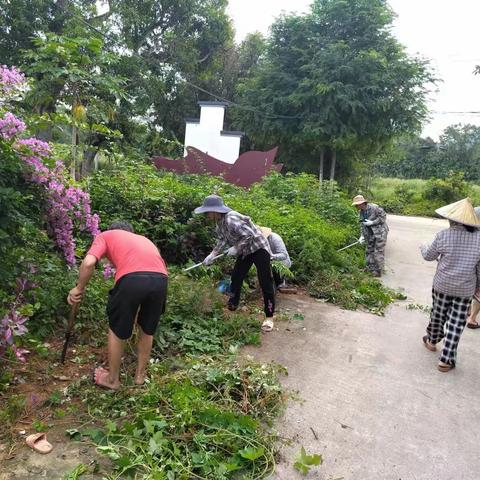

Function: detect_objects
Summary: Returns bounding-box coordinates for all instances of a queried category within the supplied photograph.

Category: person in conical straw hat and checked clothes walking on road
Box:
[420,198,480,372]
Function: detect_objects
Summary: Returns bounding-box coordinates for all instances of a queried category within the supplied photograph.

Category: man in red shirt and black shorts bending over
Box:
[67,222,168,390]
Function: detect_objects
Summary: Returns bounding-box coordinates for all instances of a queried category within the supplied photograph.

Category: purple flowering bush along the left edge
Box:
[0,66,102,361]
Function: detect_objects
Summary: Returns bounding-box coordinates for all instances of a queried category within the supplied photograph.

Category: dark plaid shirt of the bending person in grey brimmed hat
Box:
[213,210,272,256]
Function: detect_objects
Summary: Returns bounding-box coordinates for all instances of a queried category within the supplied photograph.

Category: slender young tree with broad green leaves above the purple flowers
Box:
[24,31,124,178]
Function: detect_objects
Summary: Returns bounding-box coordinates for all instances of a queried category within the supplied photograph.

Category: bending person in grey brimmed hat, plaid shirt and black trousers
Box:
[194,195,275,332]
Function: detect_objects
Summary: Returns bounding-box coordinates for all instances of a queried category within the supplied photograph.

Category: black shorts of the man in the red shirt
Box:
[107,272,168,340]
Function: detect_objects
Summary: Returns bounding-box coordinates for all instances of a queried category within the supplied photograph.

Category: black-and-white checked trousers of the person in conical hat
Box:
[427,290,471,366]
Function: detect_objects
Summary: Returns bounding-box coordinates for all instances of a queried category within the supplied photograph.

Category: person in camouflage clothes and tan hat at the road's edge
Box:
[352,195,388,277]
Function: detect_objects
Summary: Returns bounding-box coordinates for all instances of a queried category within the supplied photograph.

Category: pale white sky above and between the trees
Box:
[228,0,480,140]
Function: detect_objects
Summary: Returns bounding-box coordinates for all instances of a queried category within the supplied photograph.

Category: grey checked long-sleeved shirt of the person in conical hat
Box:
[421,225,480,297]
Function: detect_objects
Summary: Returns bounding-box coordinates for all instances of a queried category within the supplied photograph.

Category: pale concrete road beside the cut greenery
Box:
[248,216,480,480]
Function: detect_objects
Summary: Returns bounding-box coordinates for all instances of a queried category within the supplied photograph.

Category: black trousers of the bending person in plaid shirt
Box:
[229,248,275,317]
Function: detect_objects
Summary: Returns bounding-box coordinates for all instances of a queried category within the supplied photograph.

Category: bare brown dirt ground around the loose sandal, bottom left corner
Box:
[0,340,108,480]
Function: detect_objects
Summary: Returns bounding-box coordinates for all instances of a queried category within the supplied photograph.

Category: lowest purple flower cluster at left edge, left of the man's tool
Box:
[0,274,37,362]
